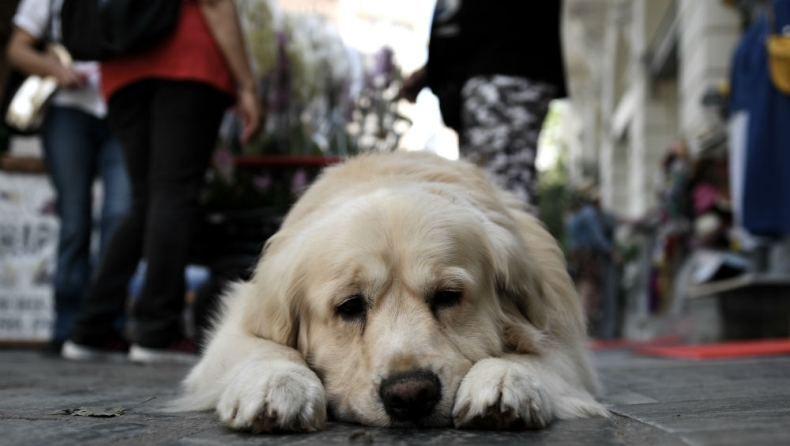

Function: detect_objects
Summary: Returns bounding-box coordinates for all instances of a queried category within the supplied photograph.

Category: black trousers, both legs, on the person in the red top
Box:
[71,79,232,348]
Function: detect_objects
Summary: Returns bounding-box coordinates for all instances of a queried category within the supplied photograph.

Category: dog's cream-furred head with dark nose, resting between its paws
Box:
[238,177,580,426]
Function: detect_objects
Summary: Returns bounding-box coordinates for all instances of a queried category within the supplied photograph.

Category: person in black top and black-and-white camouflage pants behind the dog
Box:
[400,0,566,213]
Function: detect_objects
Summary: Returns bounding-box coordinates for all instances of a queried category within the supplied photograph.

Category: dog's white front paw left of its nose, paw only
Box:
[217,360,326,433]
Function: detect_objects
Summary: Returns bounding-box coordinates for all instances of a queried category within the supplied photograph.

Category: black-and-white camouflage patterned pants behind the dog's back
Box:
[459,75,556,214]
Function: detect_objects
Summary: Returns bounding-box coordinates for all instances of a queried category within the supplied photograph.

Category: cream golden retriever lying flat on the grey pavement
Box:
[176,152,608,433]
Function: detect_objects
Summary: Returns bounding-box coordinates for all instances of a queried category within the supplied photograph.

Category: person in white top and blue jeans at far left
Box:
[6,0,130,353]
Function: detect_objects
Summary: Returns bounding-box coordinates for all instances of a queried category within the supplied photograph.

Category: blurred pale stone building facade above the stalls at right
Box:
[564,0,741,218]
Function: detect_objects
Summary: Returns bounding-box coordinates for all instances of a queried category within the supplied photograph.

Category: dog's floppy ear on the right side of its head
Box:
[489,211,584,353]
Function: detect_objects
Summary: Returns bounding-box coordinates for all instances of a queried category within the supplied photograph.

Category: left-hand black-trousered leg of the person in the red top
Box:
[71,81,151,346]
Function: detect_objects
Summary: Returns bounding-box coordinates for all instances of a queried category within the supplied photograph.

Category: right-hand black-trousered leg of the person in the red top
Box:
[132,81,230,349]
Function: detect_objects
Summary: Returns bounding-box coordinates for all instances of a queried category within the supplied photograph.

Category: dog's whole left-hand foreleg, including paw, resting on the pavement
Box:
[175,288,326,433]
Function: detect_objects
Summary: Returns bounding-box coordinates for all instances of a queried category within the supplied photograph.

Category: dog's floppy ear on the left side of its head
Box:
[238,232,304,348]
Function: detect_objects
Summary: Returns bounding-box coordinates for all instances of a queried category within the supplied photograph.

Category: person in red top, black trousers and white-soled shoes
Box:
[62,0,261,363]
